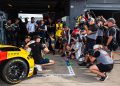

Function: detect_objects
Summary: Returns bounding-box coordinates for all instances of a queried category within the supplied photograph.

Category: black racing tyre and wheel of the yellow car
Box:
[1,59,28,84]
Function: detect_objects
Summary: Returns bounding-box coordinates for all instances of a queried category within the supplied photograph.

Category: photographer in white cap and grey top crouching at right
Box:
[89,45,114,81]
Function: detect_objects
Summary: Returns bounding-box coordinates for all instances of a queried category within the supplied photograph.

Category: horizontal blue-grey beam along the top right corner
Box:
[86,0,120,10]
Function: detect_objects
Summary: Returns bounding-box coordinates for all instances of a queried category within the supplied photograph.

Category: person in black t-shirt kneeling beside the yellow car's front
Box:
[26,36,55,71]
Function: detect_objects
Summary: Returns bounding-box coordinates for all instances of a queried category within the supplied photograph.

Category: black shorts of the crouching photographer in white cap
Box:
[96,64,113,72]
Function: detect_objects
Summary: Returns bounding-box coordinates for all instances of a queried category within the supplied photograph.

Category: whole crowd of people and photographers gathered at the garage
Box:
[5,11,119,81]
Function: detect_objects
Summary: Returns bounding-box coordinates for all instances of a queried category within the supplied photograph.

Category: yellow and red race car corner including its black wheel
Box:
[0,45,34,84]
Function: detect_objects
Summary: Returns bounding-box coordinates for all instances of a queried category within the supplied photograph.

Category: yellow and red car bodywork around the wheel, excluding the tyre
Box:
[0,45,34,77]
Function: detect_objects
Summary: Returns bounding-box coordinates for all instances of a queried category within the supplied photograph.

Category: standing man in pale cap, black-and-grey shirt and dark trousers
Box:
[79,18,98,66]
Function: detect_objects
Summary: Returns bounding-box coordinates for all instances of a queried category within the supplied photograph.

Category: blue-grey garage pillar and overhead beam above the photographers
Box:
[69,0,120,29]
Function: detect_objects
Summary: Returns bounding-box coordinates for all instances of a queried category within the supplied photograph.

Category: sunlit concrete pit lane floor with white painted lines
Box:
[0,50,120,86]
